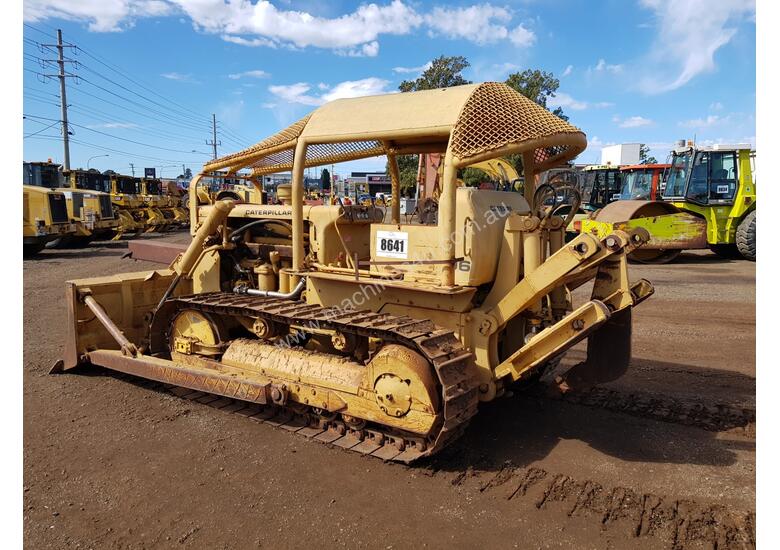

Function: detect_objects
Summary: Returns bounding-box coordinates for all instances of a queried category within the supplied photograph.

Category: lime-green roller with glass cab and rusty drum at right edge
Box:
[581,142,756,263]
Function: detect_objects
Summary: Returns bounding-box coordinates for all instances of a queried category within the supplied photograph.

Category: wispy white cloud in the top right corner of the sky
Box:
[640,0,756,94]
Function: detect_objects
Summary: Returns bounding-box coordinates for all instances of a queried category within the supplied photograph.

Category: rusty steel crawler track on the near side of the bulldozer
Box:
[150,292,478,463]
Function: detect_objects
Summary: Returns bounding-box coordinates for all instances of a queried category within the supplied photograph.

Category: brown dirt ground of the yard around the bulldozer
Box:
[23,235,755,549]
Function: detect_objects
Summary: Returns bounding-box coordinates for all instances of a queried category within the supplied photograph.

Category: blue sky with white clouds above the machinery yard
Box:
[24,0,756,176]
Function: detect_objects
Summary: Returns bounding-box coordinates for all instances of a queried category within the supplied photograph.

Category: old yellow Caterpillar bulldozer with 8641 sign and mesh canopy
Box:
[53,83,653,462]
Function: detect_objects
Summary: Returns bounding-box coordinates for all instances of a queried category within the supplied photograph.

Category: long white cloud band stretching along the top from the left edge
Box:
[24,0,536,52]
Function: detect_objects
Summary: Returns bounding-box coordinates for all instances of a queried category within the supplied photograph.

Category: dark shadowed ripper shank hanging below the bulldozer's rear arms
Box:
[562,308,631,390]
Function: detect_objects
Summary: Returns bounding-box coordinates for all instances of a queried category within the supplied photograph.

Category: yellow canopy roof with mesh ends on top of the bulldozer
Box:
[204,82,587,175]
